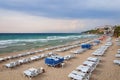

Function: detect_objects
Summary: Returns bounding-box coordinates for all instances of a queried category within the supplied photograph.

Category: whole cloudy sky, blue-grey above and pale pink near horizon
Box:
[0,0,120,33]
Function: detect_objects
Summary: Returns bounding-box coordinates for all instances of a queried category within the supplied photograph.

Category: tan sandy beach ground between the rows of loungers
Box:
[0,38,120,80]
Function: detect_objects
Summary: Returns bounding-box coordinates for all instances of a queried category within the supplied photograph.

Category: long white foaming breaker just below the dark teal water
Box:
[0,35,95,47]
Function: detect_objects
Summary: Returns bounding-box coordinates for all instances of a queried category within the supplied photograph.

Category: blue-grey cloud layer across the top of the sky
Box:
[0,0,120,19]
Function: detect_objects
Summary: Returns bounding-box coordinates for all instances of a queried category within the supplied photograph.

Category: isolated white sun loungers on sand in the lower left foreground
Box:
[23,67,45,79]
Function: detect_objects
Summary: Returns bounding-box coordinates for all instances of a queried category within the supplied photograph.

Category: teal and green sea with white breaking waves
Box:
[0,33,98,54]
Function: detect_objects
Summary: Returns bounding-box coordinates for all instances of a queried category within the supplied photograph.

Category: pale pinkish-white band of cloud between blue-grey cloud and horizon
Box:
[0,9,119,33]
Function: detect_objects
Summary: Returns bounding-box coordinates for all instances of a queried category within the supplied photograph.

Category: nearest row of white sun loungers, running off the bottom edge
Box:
[68,57,100,80]
